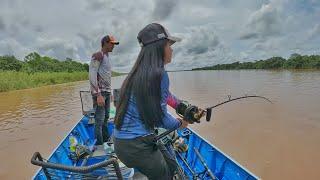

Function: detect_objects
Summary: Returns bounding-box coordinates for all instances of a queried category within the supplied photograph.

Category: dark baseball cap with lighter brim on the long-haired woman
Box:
[137,23,181,46]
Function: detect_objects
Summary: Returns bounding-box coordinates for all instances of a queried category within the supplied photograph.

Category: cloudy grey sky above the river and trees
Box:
[0,0,320,72]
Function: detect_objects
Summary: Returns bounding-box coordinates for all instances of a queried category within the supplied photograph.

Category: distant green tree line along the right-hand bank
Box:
[192,54,320,70]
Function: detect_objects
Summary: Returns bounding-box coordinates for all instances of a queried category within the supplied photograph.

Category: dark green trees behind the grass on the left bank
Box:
[0,52,89,73]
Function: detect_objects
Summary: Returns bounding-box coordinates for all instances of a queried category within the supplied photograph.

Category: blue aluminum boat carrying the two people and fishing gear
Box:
[31,91,259,180]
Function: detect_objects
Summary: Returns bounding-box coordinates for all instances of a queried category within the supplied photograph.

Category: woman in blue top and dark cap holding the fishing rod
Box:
[114,23,188,179]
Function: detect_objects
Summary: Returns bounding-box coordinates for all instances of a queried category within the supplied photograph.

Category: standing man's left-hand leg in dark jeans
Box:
[92,96,105,145]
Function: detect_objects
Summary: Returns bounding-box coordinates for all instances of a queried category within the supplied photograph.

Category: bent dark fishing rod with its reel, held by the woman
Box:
[155,95,272,141]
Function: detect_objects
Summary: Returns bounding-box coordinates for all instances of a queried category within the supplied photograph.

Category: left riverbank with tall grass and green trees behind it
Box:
[0,52,123,92]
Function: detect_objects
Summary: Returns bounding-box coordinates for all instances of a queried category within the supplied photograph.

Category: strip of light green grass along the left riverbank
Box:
[0,71,122,92]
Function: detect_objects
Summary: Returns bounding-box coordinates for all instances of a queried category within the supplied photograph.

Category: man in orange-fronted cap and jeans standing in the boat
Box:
[89,35,119,145]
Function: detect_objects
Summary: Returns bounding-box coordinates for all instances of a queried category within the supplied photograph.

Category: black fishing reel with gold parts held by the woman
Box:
[176,101,212,124]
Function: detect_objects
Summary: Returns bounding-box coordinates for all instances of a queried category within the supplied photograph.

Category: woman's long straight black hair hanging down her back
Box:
[115,39,167,130]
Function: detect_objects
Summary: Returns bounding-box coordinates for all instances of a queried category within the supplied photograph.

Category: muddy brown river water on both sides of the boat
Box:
[0,71,320,179]
